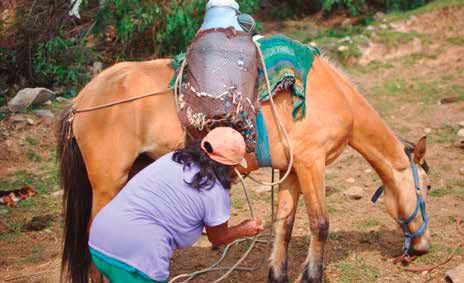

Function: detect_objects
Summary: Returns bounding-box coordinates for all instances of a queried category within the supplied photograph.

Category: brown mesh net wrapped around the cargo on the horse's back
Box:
[178,28,258,152]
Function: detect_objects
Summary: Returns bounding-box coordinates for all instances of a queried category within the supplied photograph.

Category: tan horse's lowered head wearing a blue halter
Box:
[397,136,431,255]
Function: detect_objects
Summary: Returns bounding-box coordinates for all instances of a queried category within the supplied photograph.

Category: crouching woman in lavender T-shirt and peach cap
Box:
[89,127,264,283]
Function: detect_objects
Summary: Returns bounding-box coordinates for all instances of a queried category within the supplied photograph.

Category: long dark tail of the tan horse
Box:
[57,109,92,283]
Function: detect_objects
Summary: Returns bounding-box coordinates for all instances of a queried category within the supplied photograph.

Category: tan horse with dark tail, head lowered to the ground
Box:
[58,57,429,282]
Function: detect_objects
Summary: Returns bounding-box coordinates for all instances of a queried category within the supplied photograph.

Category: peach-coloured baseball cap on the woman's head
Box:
[201,127,247,168]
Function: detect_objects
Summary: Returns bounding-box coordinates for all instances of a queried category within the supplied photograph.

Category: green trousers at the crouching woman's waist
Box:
[90,248,166,283]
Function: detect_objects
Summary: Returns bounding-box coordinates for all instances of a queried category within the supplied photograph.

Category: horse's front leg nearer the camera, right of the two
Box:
[294,158,329,282]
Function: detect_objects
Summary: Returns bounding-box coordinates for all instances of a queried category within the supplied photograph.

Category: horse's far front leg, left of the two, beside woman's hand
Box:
[268,172,300,283]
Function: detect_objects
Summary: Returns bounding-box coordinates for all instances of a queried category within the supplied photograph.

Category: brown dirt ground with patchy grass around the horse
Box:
[0,1,464,282]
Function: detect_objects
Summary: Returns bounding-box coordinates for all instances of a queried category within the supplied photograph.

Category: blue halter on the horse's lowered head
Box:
[371,155,429,253]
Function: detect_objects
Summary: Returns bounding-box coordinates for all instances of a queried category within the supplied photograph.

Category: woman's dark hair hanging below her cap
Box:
[172,139,232,189]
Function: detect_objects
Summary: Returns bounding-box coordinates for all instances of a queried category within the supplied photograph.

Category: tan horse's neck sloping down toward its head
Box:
[338,73,409,187]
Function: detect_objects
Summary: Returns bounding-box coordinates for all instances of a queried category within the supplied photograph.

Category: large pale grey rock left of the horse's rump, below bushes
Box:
[8,87,55,112]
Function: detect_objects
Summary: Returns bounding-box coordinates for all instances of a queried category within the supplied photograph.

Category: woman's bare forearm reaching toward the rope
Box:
[205,218,264,246]
